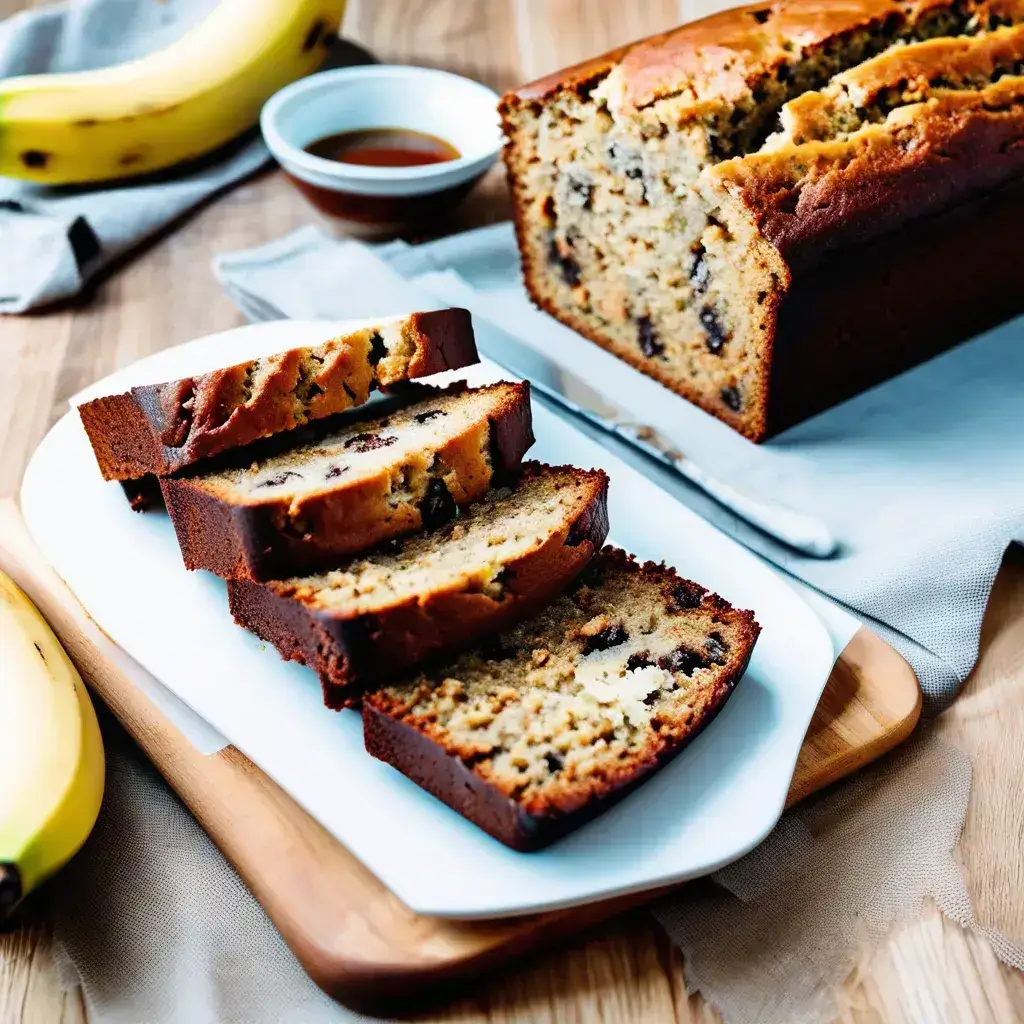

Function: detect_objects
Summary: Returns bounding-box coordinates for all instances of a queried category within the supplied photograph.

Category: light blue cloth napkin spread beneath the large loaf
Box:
[214,224,1024,715]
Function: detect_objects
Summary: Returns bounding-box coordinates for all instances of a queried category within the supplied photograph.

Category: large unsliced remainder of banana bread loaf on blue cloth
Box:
[502,0,1024,440]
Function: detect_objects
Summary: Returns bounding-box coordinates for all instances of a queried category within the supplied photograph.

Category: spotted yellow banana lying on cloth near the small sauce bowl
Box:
[0,0,345,185]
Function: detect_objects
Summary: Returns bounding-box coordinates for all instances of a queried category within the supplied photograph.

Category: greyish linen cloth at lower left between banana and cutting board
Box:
[53,716,382,1024]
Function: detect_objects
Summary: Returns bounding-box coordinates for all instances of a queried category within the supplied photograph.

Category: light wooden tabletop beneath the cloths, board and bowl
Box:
[0,0,1024,1024]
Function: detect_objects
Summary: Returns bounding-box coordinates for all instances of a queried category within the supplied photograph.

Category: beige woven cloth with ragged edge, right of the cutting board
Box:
[654,729,1024,1024]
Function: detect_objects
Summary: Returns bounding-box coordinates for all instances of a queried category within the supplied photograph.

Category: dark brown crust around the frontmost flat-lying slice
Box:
[362,547,760,851]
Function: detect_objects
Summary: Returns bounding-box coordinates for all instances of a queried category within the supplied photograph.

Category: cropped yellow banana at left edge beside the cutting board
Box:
[0,572,103,918]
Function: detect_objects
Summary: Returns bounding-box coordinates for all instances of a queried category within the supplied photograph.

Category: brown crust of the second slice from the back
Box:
[161,383,534,581]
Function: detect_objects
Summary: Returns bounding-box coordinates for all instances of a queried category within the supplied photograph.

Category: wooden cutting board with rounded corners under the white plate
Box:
[0,500,921,1002]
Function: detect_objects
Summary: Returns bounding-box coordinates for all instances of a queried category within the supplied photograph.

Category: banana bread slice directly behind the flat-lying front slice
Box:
[227,463,608,708]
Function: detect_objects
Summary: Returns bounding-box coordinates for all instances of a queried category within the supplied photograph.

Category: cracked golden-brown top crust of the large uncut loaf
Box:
[503,0,1024,268]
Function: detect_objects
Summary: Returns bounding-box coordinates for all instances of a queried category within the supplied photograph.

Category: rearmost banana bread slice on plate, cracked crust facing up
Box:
[78,309,477,491]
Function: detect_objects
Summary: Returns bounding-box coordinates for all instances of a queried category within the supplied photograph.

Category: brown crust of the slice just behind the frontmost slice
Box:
[227,463,608,709]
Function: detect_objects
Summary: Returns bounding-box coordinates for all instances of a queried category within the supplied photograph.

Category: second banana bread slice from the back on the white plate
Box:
[161,382,534,580]
